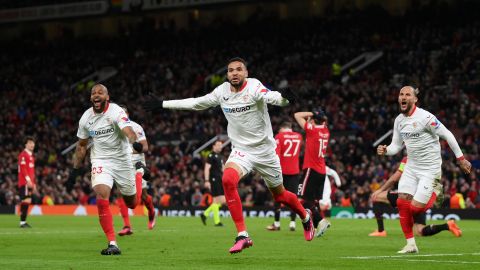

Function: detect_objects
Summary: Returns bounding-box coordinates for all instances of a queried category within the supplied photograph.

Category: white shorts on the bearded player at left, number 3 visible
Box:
[92,160,137,196]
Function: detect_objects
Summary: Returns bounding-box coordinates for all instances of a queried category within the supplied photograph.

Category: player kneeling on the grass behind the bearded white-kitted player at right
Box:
[369,156,462,237]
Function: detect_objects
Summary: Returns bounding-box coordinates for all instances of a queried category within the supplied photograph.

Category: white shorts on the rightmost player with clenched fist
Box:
[398,163,442,204]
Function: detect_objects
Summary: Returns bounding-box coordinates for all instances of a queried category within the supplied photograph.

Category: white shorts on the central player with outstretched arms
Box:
[227,148,283,188]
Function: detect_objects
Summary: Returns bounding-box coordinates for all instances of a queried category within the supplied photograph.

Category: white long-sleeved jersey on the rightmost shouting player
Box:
[387,107,463,169]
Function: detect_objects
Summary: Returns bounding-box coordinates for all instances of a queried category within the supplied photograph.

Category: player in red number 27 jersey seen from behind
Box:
[267,122,303,231]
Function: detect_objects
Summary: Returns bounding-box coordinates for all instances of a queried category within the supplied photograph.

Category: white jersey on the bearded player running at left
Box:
[77,103,132,161]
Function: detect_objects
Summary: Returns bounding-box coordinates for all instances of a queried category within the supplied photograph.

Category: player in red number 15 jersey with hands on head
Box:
[294,109,330,233]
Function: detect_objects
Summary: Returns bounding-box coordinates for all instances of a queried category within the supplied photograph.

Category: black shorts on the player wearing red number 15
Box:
[298,168,325,201]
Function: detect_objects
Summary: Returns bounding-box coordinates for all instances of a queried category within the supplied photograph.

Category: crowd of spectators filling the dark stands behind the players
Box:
[0,4,480,211]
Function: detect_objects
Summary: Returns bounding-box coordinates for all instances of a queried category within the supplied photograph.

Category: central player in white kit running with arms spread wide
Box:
[144,58,314,253]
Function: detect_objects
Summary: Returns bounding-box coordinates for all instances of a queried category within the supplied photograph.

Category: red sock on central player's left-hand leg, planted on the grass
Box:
[222,168,247,232]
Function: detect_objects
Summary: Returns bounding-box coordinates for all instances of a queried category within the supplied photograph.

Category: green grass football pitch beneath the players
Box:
[0,215,480,270]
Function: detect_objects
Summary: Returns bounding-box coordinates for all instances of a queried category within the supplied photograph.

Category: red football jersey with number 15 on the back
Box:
[303,122,330,174]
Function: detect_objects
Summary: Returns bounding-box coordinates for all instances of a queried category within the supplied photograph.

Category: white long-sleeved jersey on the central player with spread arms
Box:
[163,78,288,154]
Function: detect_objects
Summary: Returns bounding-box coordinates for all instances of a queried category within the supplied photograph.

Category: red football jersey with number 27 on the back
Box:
[275,130,303,175]
